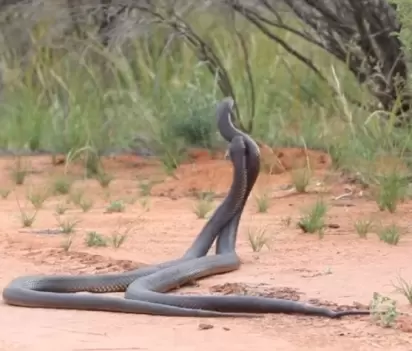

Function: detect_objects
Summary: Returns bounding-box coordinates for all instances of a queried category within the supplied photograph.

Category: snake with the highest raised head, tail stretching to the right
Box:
[125,97,370,318]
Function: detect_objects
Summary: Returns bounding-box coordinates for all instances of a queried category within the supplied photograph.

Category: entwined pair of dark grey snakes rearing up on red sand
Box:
[3,98,369,318]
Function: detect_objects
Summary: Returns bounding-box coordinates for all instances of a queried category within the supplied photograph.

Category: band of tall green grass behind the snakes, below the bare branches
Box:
[0,5,412,192]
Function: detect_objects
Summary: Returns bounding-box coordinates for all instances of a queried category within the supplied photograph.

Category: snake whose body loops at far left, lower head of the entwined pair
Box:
[3,97,253,317]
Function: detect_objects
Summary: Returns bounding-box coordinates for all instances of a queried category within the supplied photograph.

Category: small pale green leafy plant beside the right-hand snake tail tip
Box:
[370,292,399,328]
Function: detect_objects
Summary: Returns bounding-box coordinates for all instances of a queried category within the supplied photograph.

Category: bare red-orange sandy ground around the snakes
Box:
[0,149,412,351]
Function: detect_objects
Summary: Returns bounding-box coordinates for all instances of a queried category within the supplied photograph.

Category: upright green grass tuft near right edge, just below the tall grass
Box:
[376,172,408,213]
